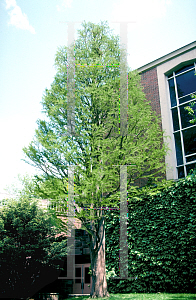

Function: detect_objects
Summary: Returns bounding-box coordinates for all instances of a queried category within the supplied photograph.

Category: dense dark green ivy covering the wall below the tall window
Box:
[106,173,196,293]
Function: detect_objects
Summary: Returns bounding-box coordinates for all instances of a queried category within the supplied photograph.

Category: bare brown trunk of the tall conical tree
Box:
[90,217,109,298]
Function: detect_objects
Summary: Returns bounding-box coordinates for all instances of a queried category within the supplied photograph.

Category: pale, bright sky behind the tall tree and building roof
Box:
[0,0,196,199]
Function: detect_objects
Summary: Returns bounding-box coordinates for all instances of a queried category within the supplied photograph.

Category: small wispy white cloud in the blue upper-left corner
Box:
[6,0,35,34]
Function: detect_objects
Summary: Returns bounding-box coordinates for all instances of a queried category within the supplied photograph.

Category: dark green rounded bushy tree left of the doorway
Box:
[0,198,67,298]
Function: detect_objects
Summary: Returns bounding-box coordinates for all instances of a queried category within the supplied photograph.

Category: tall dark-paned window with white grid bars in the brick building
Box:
[167,62,196,178]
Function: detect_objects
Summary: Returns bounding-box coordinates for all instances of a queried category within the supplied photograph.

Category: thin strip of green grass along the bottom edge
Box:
[65,293,196,300]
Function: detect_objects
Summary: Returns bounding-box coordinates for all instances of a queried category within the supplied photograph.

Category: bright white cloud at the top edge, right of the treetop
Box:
[112,0,171,23]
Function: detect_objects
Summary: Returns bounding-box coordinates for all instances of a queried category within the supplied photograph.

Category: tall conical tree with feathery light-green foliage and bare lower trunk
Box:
[24,23,167,298]
